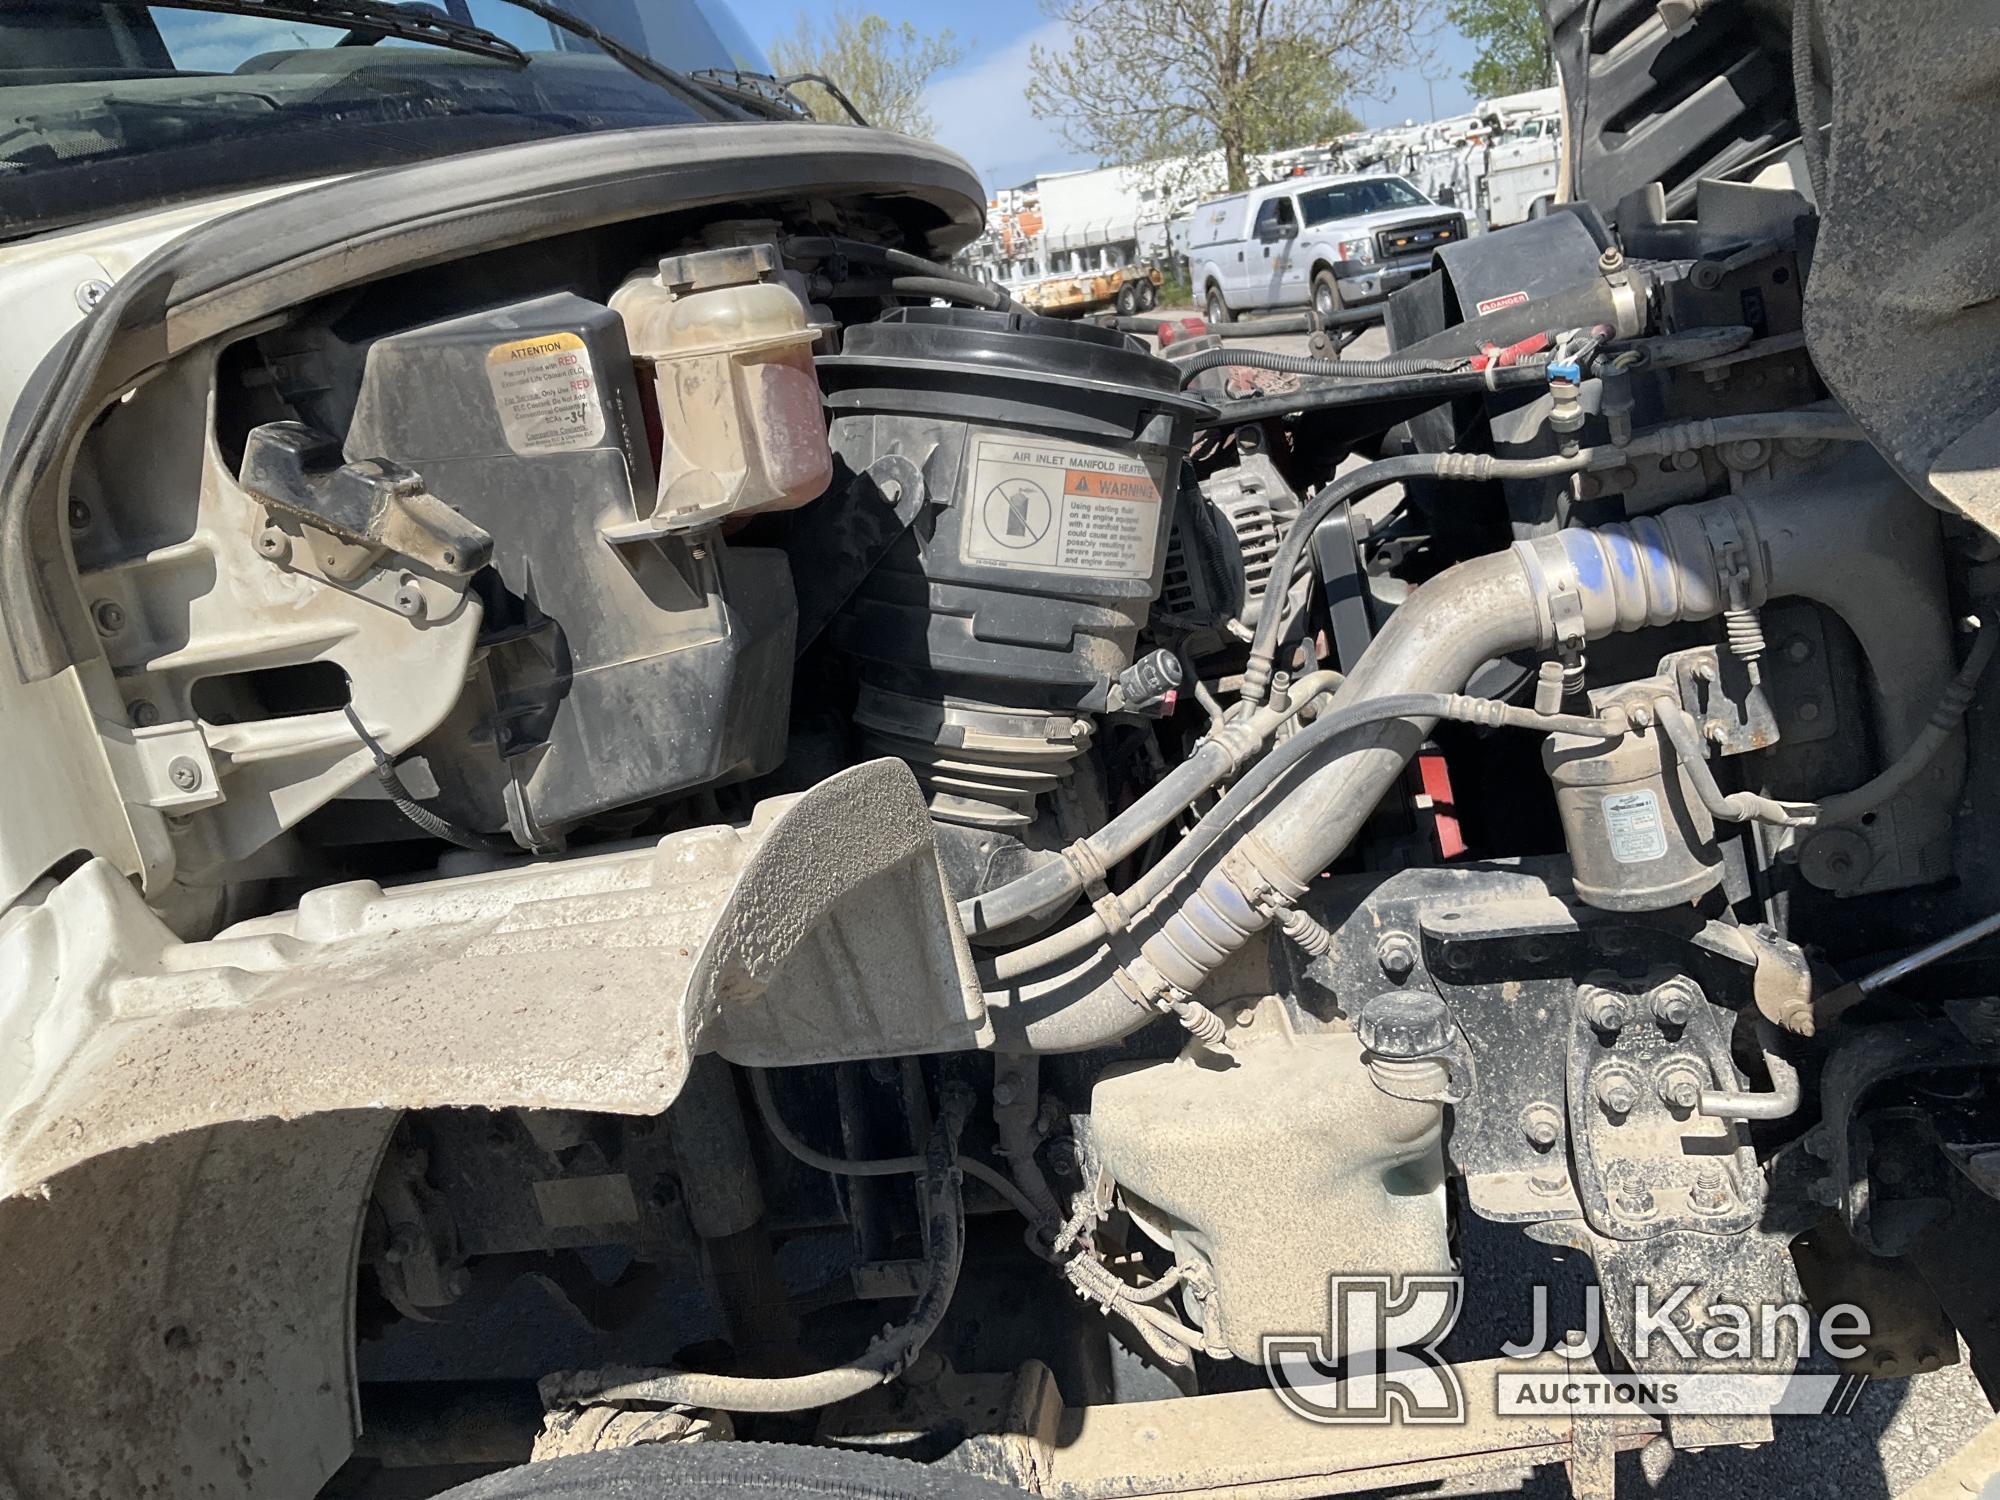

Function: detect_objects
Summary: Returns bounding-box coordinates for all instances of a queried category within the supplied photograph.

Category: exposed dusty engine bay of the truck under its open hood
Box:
[0,111,2000,1496]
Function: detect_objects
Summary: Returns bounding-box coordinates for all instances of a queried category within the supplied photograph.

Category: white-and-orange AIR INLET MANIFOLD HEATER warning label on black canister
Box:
[958,434,1160,578]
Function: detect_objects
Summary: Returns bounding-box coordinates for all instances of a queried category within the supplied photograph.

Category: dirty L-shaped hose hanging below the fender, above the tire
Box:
[540,1086,972,1412]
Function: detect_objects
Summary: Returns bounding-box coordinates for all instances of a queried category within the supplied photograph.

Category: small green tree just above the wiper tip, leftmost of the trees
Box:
[770,10,966,136]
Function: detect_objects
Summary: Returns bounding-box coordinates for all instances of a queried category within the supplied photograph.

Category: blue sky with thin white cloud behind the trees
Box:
[730,0,1472,190]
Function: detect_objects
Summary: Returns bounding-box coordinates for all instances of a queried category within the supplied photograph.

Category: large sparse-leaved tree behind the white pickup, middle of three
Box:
[1028,0,1428,192]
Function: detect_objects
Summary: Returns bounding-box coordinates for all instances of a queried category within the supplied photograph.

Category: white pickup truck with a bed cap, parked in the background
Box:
[1188,174,1466,322]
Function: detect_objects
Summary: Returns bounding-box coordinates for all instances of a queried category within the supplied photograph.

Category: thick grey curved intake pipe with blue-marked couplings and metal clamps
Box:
[986,424,1950,1052]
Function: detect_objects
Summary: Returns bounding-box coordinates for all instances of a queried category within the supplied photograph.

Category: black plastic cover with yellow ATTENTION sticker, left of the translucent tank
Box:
[346,294,796,844]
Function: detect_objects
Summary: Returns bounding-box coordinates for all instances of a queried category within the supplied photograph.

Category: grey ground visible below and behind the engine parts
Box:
[1158,308,2000,1500]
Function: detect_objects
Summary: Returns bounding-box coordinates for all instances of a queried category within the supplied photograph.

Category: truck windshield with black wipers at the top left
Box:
[0,0,768,238]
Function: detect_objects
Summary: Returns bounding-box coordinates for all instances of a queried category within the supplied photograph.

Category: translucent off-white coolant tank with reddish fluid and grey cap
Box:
[612,244,834,534]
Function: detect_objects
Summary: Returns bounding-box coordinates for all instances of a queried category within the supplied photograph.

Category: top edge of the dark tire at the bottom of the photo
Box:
[438,1442,1026,1500]
